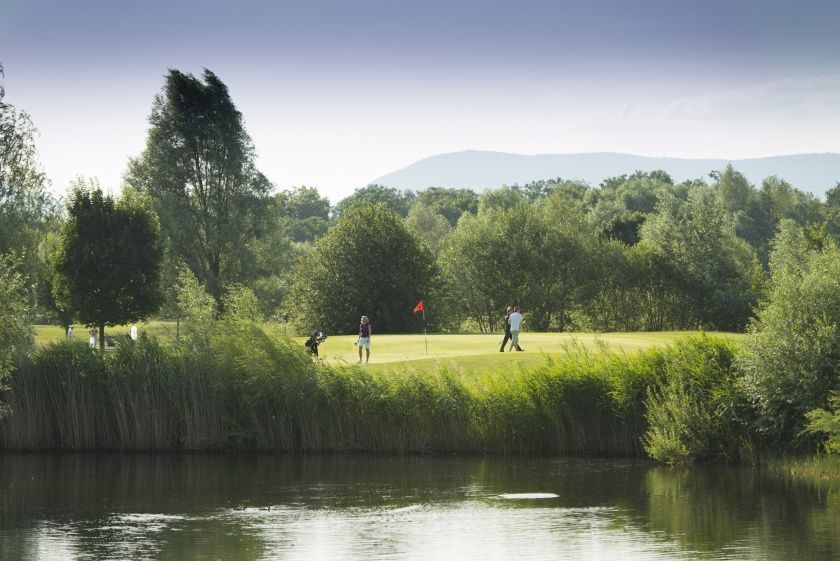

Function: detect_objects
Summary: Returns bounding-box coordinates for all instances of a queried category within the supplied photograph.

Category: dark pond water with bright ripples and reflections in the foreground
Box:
[0,454,840,561]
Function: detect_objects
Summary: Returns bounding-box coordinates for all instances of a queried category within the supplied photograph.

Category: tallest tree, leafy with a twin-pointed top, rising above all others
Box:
[127,69,271,304]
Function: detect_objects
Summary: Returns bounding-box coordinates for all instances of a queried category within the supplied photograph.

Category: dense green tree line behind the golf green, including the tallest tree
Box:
[0,65,840,331]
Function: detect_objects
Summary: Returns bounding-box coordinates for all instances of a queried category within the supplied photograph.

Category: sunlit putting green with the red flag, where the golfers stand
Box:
[310,331,743,374]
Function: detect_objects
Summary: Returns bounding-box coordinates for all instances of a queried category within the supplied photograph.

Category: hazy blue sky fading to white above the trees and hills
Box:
[0,0,840,202]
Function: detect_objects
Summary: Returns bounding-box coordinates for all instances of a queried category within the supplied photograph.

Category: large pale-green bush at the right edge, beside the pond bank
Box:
[738,221,840,446]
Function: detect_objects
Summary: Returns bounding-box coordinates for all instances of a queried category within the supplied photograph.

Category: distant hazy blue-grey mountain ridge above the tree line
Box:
[373,150,840,196]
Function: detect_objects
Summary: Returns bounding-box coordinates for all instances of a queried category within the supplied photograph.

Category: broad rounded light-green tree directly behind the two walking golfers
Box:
[441,190,596,331]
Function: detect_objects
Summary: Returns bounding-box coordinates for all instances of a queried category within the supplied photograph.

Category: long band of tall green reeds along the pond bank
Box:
[0,322,736,455]
